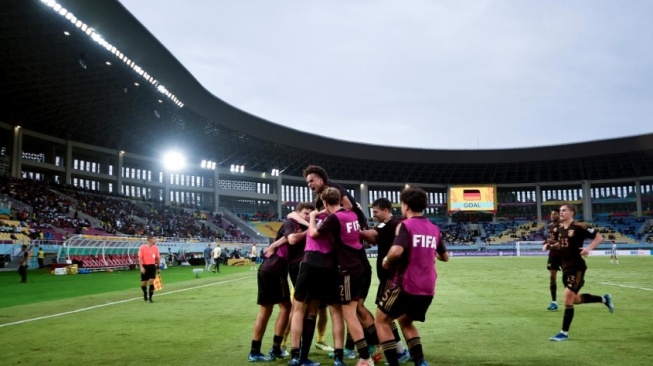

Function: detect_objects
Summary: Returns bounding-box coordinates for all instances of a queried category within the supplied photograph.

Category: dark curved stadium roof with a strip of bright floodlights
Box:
[0,0,653,184]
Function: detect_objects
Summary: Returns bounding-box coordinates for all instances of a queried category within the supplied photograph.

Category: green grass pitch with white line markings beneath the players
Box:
[0,257,653,366]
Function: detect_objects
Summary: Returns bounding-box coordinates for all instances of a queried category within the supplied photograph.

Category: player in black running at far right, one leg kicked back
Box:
[545,203,614,342]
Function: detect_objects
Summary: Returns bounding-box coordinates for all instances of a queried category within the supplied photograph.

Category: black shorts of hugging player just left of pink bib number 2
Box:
[295,263,339,304]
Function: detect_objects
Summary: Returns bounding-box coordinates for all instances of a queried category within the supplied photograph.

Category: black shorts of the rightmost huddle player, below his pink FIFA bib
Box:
[376,286,433,322]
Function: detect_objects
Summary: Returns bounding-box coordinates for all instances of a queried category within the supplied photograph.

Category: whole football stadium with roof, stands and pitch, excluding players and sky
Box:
[0,0,653,365]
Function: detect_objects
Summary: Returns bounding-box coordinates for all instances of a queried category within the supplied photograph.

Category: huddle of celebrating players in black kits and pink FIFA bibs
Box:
[248,165,449,366]
